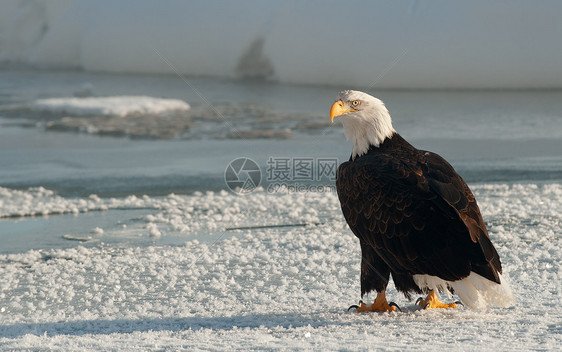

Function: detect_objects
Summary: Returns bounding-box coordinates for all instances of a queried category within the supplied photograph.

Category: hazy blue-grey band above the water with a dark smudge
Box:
[0,0,562,88]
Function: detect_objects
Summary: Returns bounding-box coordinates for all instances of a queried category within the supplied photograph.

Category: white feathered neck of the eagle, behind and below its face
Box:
[341,106,396,159]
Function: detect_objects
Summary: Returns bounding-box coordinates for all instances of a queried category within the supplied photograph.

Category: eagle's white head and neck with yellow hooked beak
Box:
[330,90,396,159]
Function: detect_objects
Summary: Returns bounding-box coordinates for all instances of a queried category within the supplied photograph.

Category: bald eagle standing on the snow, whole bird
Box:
[330,90,513,312]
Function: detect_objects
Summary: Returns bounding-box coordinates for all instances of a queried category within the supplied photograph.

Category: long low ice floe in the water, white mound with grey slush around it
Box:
[17,96,324,139]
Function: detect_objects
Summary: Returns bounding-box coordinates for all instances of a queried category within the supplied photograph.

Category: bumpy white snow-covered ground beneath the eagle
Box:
[0,184,562,351]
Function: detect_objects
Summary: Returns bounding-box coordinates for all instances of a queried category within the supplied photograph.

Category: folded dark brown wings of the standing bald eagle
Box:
[336,153,501,282]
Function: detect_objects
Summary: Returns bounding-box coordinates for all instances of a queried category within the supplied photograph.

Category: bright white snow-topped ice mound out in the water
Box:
[31,96,190,117]
